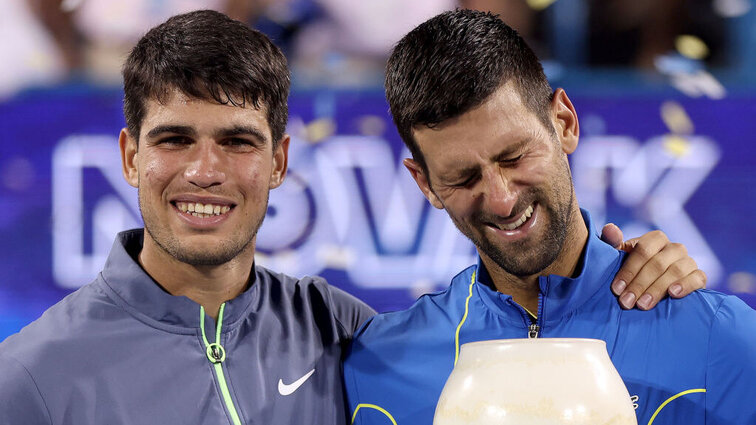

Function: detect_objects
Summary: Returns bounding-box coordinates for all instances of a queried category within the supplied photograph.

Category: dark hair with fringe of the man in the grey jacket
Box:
[123,10,290,146]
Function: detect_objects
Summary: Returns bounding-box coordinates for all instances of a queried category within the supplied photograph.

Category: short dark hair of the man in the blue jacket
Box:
[386,9,553,173]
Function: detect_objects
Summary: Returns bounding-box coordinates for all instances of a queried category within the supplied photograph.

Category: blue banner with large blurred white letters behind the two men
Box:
[0,87,756,340]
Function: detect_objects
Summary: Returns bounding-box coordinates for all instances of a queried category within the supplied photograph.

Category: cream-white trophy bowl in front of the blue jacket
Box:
[433,338,637,425]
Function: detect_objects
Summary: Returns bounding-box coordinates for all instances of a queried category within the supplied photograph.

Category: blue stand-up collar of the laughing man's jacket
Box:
[475,209,624,323]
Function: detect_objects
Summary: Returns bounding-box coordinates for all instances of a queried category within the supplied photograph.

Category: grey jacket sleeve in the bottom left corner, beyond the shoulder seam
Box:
[0,355,52,425]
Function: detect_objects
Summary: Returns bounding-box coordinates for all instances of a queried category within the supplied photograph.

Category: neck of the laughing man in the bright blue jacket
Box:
[480,205,588,314]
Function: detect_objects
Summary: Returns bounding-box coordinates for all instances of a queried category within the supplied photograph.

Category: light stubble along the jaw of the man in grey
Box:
[139,189,269,266]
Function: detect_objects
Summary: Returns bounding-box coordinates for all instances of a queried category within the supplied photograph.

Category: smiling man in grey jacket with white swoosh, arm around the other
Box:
[0,6,702,425]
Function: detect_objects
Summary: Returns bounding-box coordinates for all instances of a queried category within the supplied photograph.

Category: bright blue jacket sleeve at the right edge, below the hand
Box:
[706,296,756,425]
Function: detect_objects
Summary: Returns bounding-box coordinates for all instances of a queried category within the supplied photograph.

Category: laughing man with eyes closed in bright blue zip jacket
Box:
[344,10,756,425]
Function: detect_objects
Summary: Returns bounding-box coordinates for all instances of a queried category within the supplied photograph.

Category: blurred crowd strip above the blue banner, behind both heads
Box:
[0,0,756,97]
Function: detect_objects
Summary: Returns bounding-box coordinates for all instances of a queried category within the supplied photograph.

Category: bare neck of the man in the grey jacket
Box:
[139,231,255,319]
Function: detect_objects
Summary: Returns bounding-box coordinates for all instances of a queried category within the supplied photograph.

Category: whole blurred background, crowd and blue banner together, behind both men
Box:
[0,0,756,340]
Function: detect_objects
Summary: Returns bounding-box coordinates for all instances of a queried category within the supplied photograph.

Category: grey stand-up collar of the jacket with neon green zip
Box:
[101,229,264,330]
